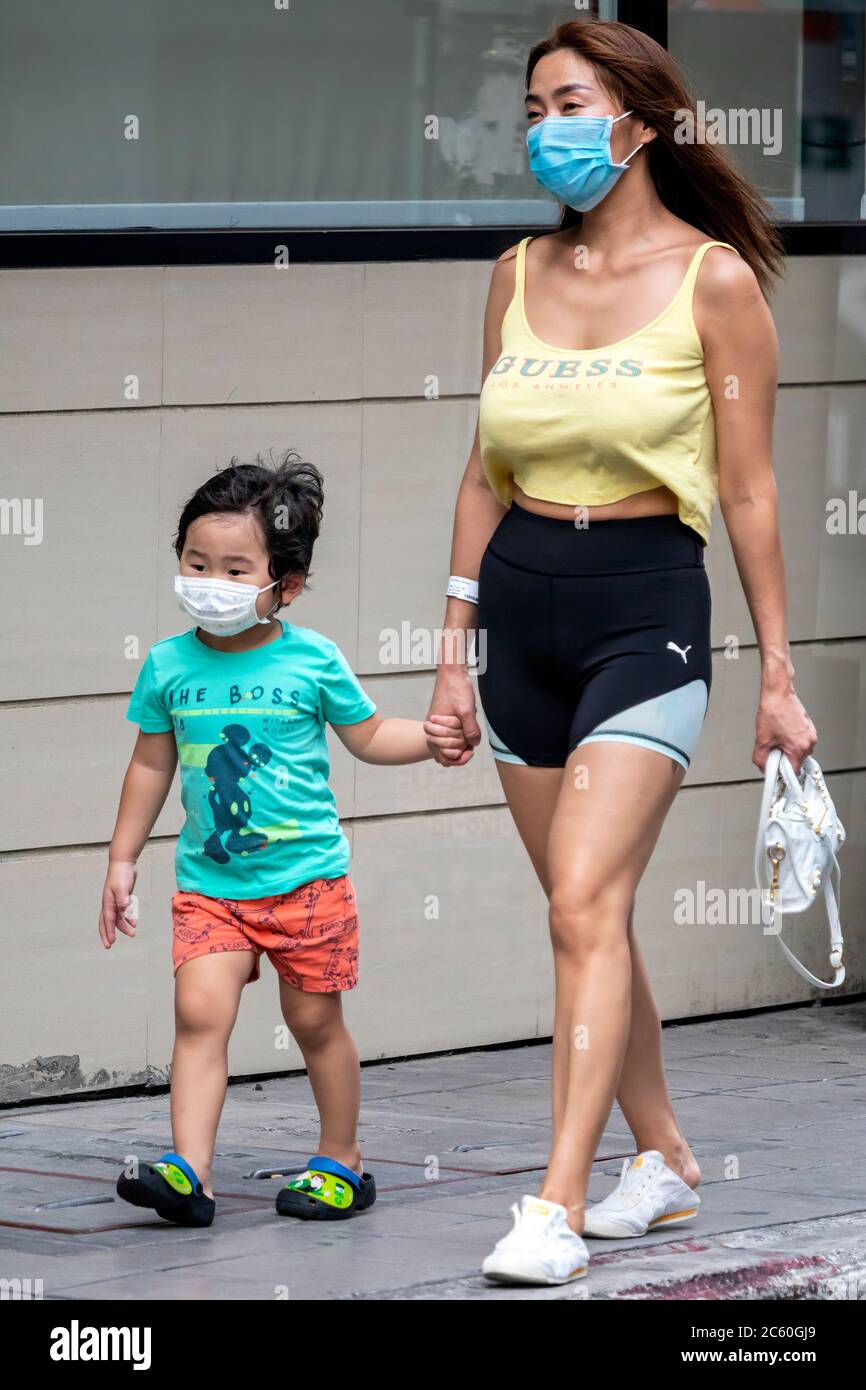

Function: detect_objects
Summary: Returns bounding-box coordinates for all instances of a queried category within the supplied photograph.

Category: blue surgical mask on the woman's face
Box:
[527,111,642,213]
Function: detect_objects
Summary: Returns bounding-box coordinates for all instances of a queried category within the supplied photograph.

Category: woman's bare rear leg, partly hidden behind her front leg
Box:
[496,745,701,1187]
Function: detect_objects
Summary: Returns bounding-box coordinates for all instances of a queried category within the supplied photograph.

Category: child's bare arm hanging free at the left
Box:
[99,731,178,949]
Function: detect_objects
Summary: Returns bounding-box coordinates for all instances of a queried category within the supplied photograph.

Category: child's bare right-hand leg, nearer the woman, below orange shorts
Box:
[279,979,361,1173]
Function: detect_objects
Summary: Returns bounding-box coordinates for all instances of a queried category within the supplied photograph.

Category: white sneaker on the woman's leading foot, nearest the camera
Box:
[481,1197,589,1284]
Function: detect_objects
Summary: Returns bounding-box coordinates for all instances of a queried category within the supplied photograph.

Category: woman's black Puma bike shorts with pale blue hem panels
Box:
[478,503,712,767]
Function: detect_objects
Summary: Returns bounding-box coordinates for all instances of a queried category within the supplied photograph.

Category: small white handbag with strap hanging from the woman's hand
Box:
[755,748,845,990]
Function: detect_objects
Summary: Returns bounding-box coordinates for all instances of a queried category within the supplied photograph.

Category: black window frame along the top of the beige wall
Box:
[0,0,866,270]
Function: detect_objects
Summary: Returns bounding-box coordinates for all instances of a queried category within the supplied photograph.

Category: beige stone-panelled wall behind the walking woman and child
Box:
[0,257,866,1099]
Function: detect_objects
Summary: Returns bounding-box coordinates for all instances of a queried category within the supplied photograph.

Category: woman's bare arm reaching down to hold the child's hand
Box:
[428,246,517,767]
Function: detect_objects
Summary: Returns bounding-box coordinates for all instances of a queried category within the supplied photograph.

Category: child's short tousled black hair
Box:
[174,449,325,580]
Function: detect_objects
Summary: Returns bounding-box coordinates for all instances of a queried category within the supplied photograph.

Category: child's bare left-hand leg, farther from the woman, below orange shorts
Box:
[171,951,254,1197]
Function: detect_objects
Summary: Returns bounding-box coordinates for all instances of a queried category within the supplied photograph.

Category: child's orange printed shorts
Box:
[171,874,357,994]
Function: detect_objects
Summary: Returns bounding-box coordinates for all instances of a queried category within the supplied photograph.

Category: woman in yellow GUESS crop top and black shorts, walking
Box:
[431,21,816,1284]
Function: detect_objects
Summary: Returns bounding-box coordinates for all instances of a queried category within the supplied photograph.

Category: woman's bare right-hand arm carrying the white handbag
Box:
[695,247,817,771]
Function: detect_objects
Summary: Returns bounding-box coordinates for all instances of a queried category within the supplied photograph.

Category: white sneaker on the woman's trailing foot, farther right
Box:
[584,1148,701,1240]
